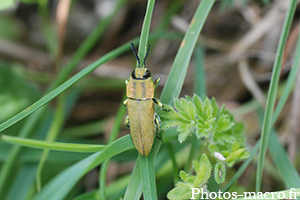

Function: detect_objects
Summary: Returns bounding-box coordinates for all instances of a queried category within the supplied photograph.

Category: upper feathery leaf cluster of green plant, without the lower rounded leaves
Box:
[158,95,247,158]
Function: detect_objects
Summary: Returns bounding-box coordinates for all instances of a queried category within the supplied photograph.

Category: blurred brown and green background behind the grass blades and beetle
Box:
[0,0,300,198]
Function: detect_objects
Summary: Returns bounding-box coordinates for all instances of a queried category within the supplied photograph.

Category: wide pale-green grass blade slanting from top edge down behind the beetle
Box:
[124,0,215,200]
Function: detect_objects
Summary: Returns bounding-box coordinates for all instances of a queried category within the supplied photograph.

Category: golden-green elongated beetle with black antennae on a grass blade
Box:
[123,43,163,156]
